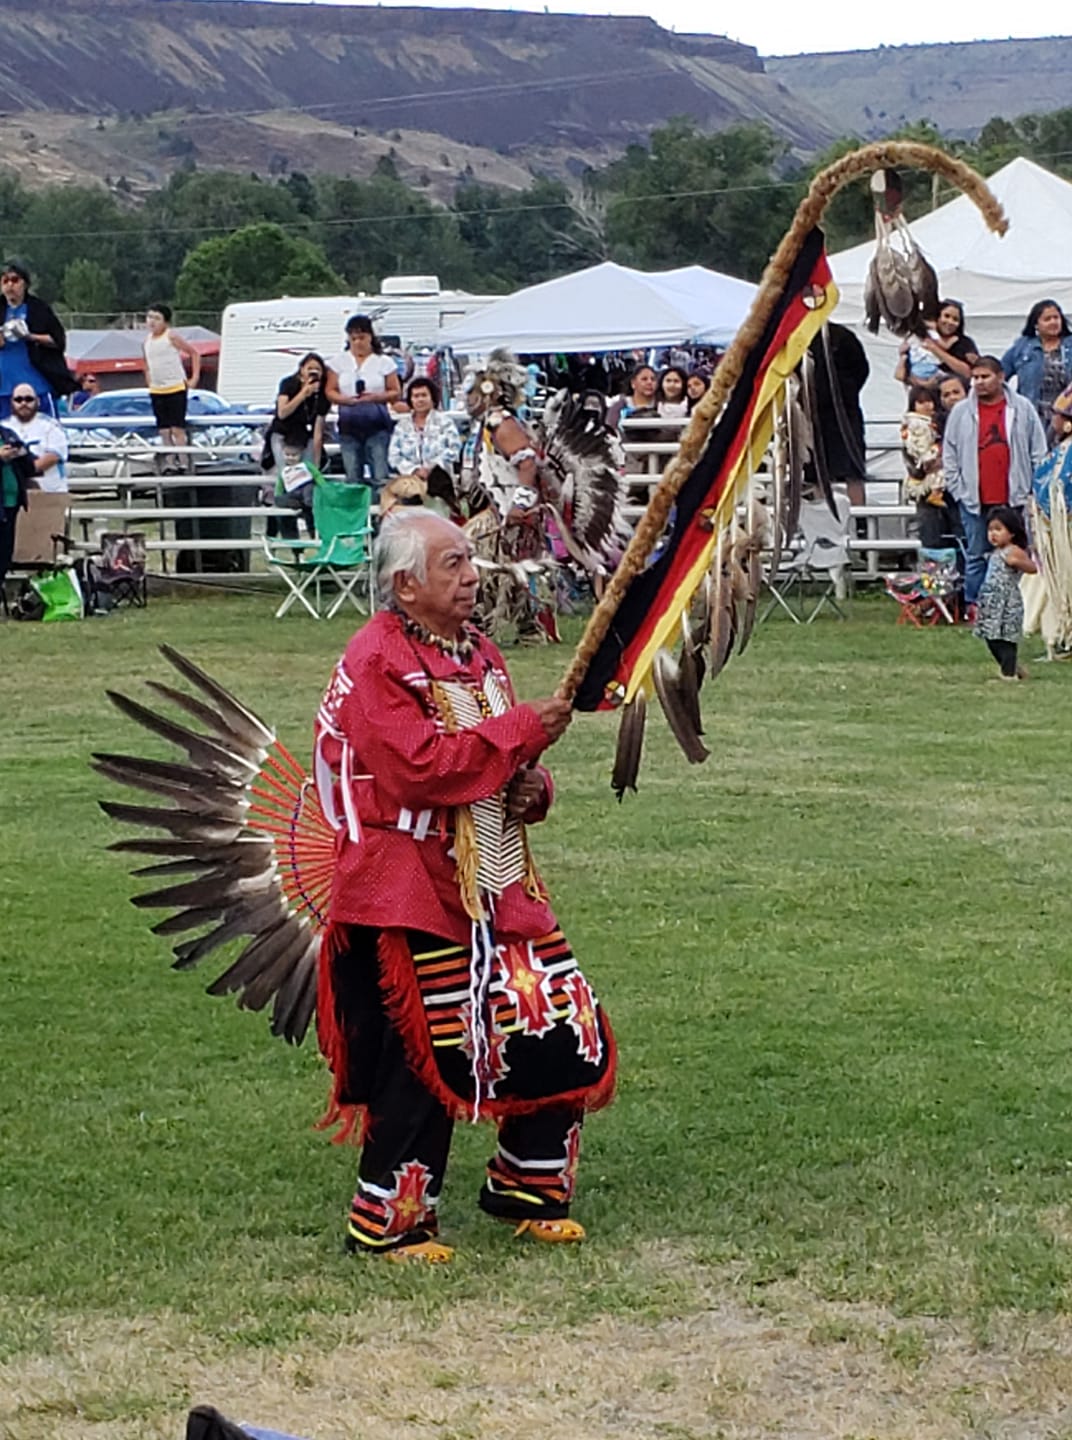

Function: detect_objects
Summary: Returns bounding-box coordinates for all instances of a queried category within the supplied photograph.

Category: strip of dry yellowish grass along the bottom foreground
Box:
[0,1247,1072,1440]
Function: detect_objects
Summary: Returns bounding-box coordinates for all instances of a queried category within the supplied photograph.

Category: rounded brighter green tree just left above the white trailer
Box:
[174,223,343,315]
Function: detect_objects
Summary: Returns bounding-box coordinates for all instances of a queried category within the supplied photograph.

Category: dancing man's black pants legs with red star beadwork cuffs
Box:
[346,933,582,1250]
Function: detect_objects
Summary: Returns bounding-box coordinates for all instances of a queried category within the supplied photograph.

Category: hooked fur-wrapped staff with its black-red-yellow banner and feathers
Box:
[558,141,1007,798]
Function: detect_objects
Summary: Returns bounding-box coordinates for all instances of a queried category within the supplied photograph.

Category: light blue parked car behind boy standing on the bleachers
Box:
[63,390,269,464]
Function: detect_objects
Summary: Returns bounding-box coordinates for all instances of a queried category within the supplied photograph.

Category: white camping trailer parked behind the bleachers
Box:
[216,275,501,409]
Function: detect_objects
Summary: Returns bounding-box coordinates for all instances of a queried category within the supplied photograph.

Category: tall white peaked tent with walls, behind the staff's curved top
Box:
[830,158,1072,420]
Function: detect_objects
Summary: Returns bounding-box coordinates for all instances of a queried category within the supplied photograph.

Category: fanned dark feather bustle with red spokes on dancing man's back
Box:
[94,645,334,1044]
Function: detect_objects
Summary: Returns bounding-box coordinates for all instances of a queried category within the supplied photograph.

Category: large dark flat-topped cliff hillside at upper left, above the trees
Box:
[0,0,831,194]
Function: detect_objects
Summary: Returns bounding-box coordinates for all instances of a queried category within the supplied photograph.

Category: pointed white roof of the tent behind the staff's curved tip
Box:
[830,156,1072,291]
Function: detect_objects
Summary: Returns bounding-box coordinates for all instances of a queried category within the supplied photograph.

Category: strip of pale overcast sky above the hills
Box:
[337,0,1072,55]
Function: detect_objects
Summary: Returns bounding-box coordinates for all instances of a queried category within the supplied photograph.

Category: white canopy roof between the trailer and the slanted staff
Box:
[438,261,755,354]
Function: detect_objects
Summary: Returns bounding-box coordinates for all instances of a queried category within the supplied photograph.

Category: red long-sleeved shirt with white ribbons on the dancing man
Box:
[316,611,556,945]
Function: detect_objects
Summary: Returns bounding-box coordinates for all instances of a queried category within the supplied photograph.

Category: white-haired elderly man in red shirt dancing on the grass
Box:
[316,511,615,1263]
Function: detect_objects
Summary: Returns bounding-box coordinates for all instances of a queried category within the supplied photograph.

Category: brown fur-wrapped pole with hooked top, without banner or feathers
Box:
[556,141,1009,714]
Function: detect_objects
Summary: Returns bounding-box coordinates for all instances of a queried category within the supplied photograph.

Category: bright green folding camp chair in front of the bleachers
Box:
[264,480,373,621]
